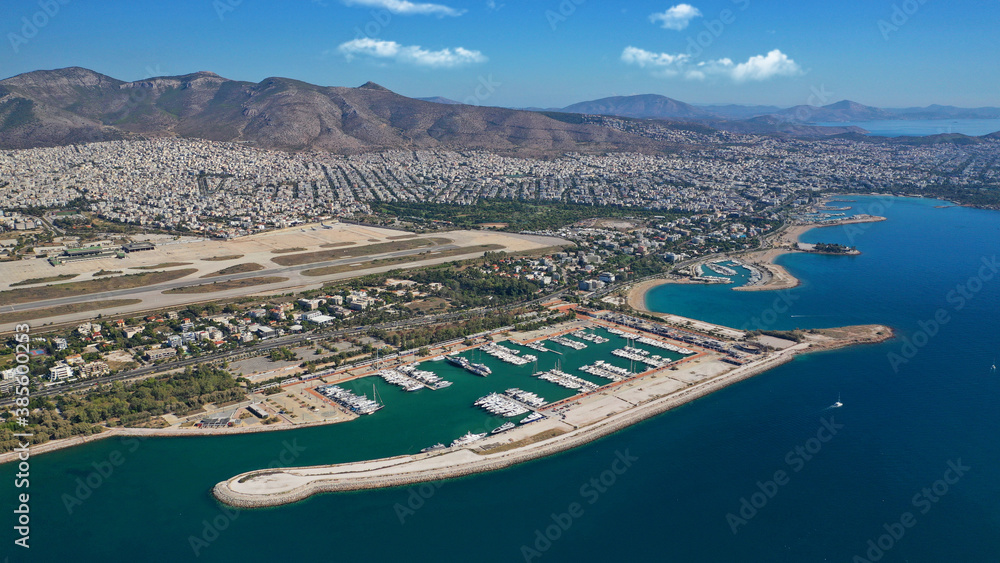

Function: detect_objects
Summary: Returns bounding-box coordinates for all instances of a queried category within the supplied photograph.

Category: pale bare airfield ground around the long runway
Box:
[0,223,567,332]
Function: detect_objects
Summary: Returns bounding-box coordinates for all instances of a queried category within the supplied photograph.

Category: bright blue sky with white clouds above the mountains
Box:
[0,0,1000,107]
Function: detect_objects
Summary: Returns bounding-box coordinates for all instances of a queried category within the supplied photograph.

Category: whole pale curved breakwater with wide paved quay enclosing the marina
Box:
[212,325,893,508]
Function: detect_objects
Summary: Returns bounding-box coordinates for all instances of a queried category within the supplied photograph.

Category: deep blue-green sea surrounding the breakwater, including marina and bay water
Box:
[0,198,1000,563]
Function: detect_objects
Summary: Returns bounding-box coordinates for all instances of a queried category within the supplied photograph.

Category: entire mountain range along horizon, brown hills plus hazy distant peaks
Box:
[0,67,1000,155]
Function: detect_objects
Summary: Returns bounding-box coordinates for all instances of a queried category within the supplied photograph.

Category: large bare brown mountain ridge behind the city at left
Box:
[0,67,671,153]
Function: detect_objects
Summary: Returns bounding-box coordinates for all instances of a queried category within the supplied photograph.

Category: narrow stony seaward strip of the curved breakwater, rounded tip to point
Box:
[212,325,893,508]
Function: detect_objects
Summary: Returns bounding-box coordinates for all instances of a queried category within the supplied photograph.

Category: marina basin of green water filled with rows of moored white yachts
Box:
[321,322,711,436]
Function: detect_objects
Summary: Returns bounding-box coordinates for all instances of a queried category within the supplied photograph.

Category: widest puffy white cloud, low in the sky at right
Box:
[622,46,802,82]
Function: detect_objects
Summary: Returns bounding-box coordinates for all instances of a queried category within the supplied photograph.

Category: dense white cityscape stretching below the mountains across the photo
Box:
[0,132,1000,238]
